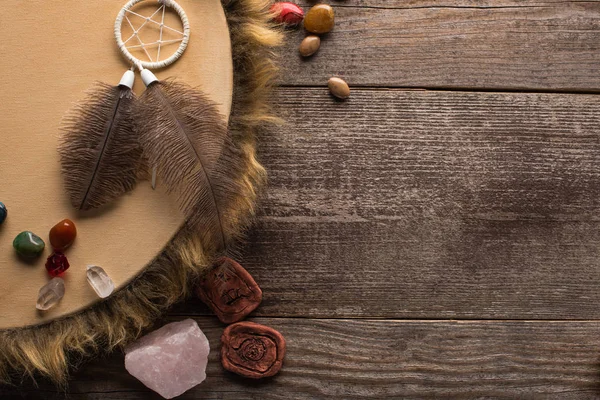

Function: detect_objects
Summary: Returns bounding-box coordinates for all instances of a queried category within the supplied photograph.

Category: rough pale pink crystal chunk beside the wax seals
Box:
[125,319,210,399]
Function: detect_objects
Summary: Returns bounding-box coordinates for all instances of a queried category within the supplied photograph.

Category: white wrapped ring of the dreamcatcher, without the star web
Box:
[115,0,190,70]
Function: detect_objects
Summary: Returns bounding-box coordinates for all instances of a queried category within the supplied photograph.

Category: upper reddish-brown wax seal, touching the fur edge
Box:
[196,257,262,324]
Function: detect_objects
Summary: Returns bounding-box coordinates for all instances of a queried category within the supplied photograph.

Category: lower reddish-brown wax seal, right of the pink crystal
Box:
[221,322,285,379]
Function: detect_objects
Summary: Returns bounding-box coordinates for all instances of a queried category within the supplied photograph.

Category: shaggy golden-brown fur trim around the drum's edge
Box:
[0,0,282,386]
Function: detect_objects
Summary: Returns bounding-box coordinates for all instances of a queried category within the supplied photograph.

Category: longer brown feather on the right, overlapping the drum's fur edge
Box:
[138,81,243,253]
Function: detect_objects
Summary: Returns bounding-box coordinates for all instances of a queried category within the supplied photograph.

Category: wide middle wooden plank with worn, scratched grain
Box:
[170,88,600,319]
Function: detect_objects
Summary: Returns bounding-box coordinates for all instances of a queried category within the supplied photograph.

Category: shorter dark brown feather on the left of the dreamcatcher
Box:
[59,83,142,210]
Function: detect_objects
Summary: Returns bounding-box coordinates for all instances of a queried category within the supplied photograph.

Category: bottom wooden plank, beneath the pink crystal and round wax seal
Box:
[0,318,600,400]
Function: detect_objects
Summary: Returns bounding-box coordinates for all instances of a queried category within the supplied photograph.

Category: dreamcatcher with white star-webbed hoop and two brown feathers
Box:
[59,0,242,254]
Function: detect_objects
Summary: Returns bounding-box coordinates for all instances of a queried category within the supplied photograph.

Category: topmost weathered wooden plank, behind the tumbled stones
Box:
[281,0,600,92]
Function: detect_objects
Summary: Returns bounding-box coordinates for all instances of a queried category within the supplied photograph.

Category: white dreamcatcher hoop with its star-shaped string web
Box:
[114,0,190,70]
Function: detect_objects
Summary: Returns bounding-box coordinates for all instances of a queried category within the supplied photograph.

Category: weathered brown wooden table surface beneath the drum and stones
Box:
[7,0,600,400]
